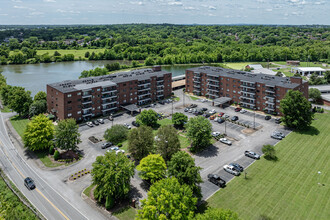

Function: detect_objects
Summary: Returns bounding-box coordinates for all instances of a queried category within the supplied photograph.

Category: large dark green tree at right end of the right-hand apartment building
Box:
[280,90,313,129]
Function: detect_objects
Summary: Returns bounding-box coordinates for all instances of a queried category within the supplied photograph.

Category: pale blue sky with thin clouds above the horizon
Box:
[0,0,330,25]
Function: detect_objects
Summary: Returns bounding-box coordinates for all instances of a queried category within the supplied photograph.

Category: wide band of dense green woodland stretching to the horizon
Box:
[0,24,330,64]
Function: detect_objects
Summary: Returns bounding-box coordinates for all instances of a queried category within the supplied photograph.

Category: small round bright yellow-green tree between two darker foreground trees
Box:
[136,154,167,184]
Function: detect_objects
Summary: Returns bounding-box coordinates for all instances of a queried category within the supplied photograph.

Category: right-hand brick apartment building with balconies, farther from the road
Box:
[186,66,308,114]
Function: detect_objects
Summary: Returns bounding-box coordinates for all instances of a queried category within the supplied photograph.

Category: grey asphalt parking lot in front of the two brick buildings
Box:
[73,90,290,199]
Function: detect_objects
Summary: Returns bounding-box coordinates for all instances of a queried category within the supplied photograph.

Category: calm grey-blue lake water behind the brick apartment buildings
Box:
[0,60,201,96]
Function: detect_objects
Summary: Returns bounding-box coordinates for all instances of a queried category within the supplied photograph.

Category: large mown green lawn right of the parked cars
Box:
[208,113,330,219]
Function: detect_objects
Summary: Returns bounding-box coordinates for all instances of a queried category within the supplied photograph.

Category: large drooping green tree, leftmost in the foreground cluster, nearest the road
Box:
[91,152,134,208]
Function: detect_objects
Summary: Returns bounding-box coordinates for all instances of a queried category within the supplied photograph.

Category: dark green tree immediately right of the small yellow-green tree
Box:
[168,151,203,199]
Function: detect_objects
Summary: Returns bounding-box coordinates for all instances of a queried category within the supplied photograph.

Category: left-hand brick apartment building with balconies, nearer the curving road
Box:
[47,66,172,121]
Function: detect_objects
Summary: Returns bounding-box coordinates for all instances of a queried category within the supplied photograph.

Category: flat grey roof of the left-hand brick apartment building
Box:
[48,68,169,93]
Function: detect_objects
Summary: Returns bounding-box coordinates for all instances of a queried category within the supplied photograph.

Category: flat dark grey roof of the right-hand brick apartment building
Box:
[187,66,306,89]
